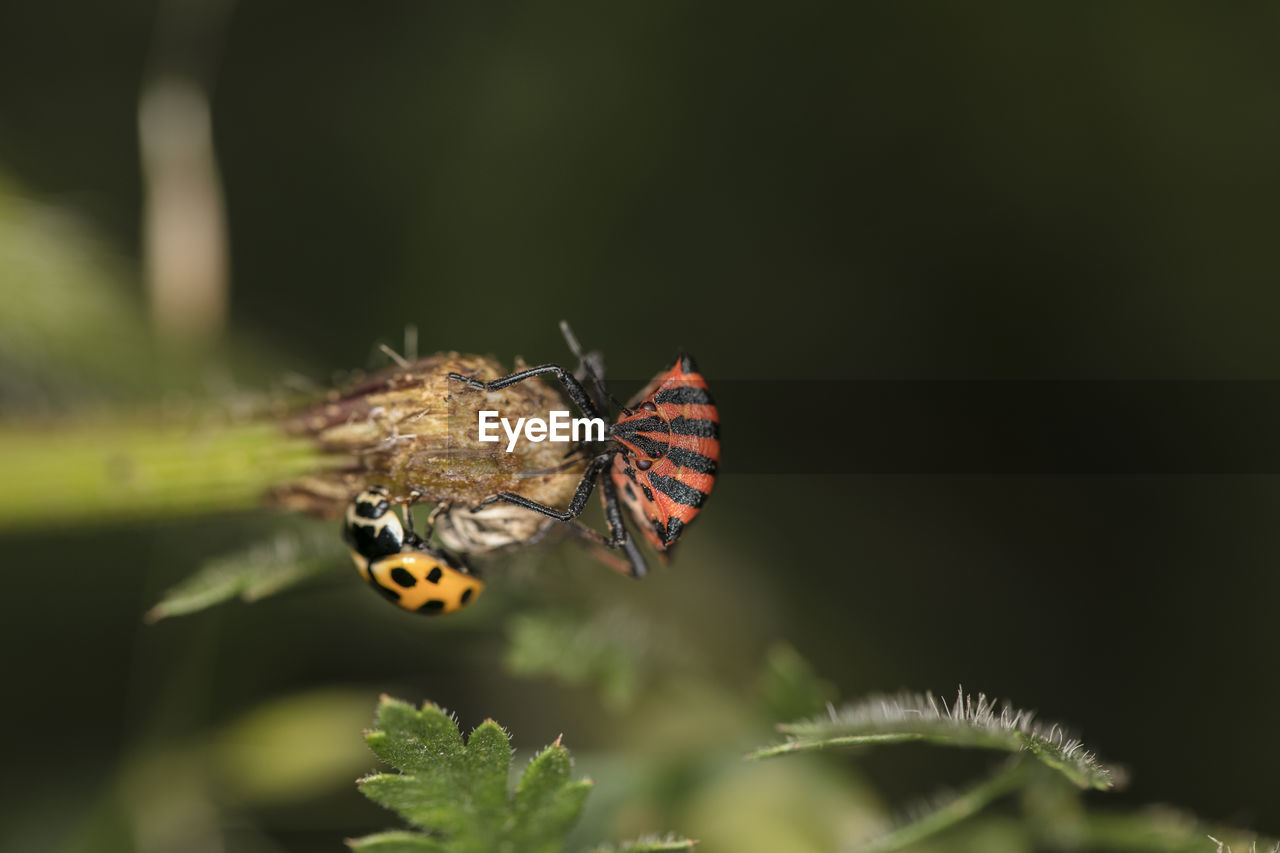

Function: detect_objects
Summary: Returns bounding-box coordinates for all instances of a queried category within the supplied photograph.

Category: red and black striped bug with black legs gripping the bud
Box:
[449,323,719,578]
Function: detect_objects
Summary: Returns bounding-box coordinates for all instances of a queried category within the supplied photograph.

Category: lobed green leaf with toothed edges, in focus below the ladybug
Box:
[348,697,591,853]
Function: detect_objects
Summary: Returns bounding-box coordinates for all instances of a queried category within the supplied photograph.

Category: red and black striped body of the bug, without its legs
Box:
[611,355,719,551]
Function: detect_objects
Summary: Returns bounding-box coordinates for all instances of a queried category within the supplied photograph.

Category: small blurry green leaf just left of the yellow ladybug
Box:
[146,525,342,622]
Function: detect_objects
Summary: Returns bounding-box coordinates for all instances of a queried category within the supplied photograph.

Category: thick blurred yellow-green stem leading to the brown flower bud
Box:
[0,419,335,529]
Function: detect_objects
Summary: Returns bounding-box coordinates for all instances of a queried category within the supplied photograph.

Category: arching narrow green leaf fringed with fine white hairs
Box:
[749,690,1120,790]
